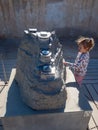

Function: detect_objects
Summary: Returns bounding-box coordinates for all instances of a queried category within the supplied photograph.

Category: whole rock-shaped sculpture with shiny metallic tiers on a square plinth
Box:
[15,29,66,110]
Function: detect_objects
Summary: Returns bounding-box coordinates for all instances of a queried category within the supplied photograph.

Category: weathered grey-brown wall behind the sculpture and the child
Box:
[0,0,98,37]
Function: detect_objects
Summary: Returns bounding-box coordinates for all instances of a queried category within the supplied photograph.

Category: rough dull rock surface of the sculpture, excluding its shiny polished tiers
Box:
[15,31,66,110]
